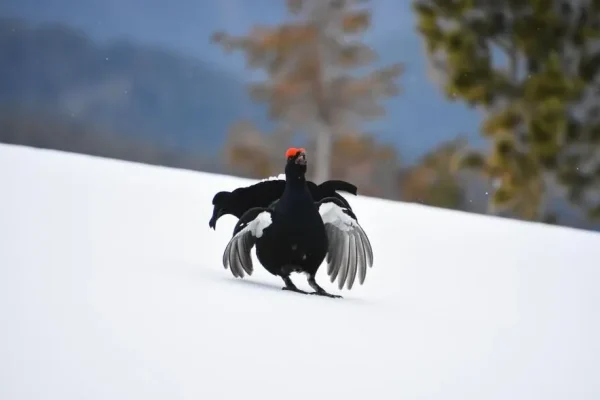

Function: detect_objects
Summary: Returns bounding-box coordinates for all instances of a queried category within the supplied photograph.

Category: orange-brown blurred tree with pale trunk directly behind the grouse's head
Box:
[213,0,402,182]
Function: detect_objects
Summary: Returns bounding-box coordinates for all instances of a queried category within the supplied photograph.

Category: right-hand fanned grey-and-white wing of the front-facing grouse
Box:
[317,197,373,289]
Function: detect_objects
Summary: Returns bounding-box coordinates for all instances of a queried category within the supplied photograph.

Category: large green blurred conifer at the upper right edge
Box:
[413,0,600,220]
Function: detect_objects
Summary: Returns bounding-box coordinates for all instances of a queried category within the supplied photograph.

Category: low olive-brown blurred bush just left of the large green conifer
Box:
[400,138,466,210]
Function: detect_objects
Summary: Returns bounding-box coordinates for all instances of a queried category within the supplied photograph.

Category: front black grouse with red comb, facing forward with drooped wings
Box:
[218,149,373,297]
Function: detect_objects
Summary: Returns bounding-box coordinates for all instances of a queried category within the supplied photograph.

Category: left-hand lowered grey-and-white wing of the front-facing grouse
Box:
[223,207,272,278]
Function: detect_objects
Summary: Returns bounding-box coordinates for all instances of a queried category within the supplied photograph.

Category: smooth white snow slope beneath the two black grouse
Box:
[0,145,600,400]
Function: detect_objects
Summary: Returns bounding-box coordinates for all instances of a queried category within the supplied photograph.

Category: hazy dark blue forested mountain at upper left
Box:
[0,19,268,153]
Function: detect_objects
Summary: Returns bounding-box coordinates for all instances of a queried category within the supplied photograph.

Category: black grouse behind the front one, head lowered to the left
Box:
[208,153,358,229]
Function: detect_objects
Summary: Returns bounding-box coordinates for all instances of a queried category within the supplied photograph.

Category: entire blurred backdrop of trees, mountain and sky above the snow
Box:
[0,0,600,230]
